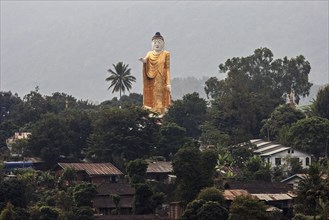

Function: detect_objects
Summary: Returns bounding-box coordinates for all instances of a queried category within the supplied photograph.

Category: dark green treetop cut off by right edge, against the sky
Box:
[312,85,329,119]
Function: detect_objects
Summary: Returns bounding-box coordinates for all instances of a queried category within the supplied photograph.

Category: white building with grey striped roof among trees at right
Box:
[250,139,311,168]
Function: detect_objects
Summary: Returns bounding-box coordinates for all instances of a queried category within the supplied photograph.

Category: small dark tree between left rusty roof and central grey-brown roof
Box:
[126,159,148,185]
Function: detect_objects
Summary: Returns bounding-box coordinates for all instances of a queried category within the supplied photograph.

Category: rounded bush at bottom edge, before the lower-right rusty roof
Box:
[229,195,268,220]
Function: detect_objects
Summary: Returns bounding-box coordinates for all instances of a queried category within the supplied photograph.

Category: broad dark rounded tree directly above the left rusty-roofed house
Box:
[25,111,91,168]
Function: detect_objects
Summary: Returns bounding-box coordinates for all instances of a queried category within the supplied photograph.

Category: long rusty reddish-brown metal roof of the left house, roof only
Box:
[58,163,123,176]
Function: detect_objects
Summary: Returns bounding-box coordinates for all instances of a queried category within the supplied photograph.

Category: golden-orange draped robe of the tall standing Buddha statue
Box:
[143,51,171,114]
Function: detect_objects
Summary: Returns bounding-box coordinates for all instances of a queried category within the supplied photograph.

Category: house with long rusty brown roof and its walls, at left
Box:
[53,163,124,185]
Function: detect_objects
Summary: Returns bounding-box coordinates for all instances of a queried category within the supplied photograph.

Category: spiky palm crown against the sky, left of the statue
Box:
[105,62,136,99]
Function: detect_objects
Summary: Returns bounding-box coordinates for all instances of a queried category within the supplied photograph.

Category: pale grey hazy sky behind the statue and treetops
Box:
[0,0,329,102]
